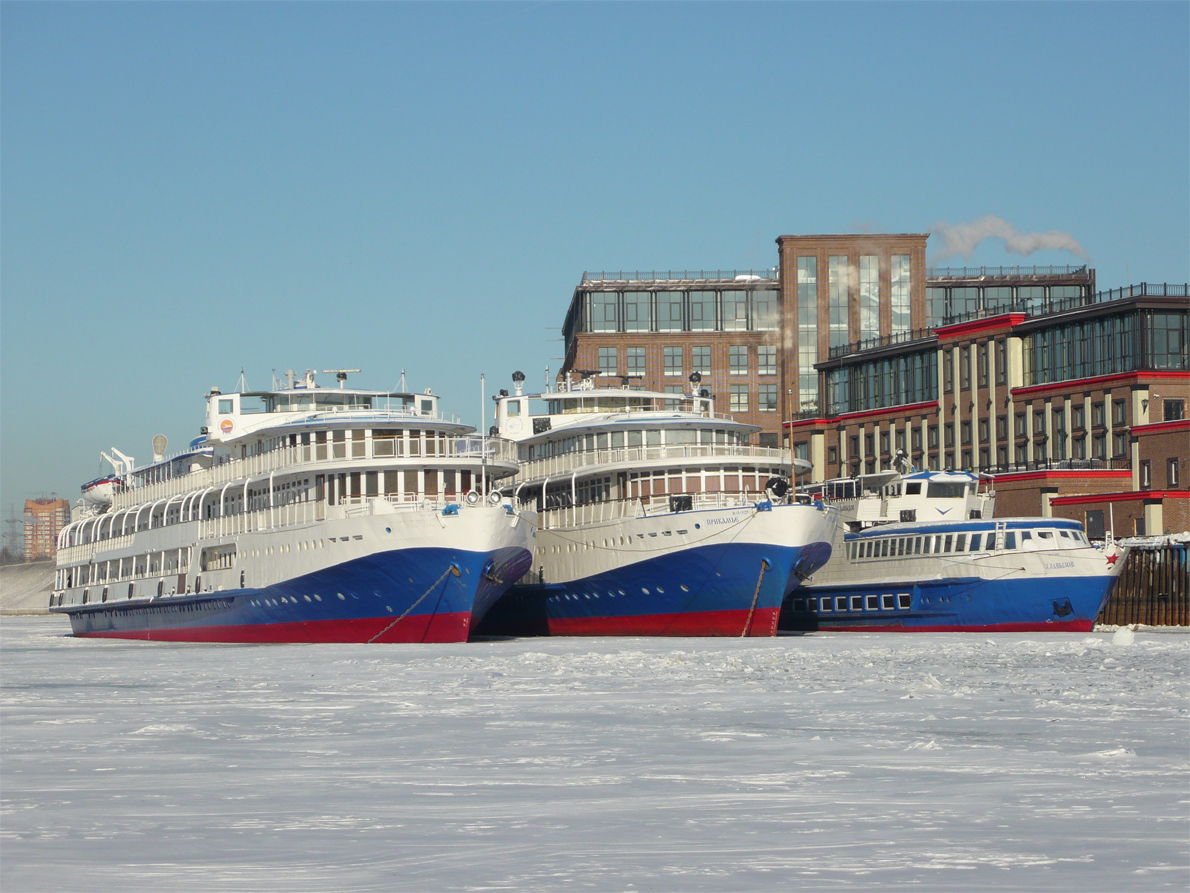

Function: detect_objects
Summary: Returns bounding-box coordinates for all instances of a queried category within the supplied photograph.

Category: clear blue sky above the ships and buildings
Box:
[0,2,1190,507]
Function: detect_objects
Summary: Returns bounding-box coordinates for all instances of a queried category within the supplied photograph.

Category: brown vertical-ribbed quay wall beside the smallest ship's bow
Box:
[1096,545,1190,626]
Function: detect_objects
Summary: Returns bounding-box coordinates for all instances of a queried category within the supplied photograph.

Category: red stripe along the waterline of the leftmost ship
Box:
[75,611,471,644]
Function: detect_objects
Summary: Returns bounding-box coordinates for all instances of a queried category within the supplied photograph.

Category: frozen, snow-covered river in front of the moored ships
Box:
[0,617,1190,893]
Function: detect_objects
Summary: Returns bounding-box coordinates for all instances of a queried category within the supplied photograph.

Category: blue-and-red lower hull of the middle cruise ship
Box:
[476,543,831,636]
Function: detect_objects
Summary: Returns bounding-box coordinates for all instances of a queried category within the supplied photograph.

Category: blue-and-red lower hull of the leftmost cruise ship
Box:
[60,547,532,642]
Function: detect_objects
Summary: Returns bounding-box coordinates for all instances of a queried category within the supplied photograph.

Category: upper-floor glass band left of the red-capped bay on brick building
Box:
[827,350,938,416]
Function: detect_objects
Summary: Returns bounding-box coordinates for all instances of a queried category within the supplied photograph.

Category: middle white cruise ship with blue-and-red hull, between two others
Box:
[478,373,835,636]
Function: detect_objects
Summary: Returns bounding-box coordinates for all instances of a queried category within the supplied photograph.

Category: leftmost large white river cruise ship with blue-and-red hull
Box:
[50,369,536,642]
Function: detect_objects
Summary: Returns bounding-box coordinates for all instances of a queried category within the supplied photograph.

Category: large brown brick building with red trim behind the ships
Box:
[563,233,1190,535]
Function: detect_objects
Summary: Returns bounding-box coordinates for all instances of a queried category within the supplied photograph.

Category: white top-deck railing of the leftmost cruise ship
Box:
[109,435,516,511]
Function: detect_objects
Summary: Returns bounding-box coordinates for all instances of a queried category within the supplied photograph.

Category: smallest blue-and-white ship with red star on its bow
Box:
[781,472,1127,632]
